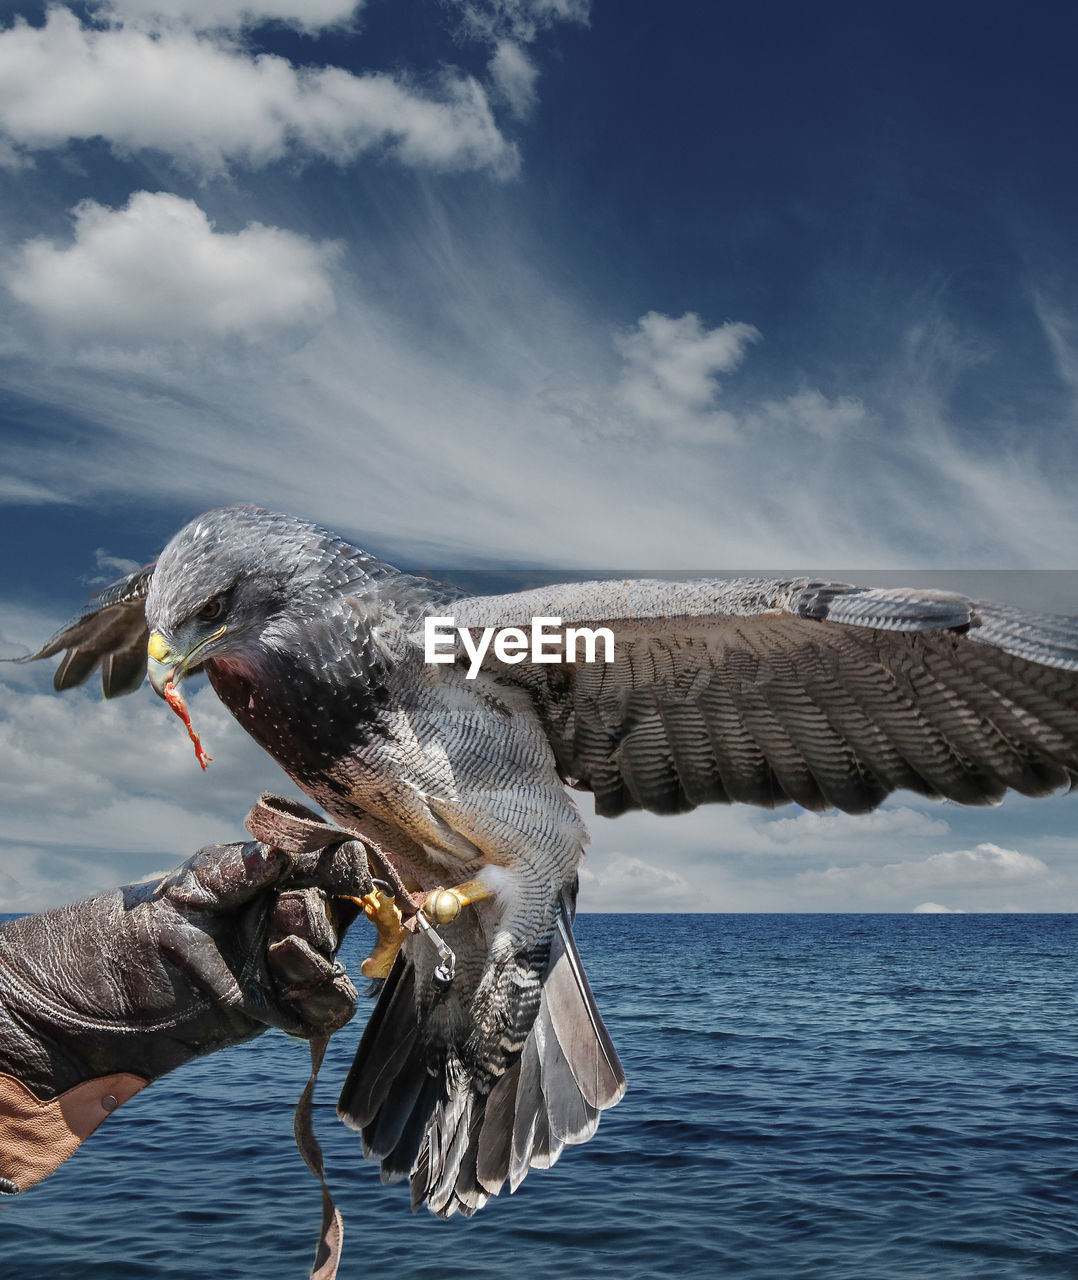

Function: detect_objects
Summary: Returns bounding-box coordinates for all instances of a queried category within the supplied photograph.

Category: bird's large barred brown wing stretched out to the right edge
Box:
[437,579,1078,815]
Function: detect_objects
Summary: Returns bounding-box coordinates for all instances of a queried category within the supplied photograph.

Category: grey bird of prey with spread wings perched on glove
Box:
[14,507,1078,1216]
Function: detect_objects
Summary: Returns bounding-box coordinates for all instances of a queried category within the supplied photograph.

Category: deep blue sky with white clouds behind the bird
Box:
[0,0,1078,910]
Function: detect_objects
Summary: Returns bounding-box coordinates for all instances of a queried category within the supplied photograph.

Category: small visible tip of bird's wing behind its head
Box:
[13,564,154,698]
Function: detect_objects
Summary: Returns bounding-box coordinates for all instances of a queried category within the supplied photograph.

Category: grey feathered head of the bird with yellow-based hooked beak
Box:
[146,507,325,696]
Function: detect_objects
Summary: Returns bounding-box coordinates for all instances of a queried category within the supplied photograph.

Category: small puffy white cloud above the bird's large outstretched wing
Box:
[616,311,760,442]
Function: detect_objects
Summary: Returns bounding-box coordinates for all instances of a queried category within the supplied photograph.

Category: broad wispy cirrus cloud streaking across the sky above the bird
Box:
[5,285,1078,571]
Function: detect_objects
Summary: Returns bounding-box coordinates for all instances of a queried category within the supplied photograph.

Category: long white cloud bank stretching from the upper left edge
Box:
[0,8,517,174]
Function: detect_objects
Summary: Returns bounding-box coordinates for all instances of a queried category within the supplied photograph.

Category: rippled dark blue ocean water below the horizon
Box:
[0,915,1078,1280]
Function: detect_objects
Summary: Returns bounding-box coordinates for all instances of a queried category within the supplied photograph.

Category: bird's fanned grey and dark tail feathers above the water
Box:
[338,895,625,1217]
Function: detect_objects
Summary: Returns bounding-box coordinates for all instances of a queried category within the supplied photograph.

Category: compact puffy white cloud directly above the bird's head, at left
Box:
[8,191,335,344]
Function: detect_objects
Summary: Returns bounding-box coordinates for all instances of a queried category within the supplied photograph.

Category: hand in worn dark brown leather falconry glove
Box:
[0,805,371,1193]
